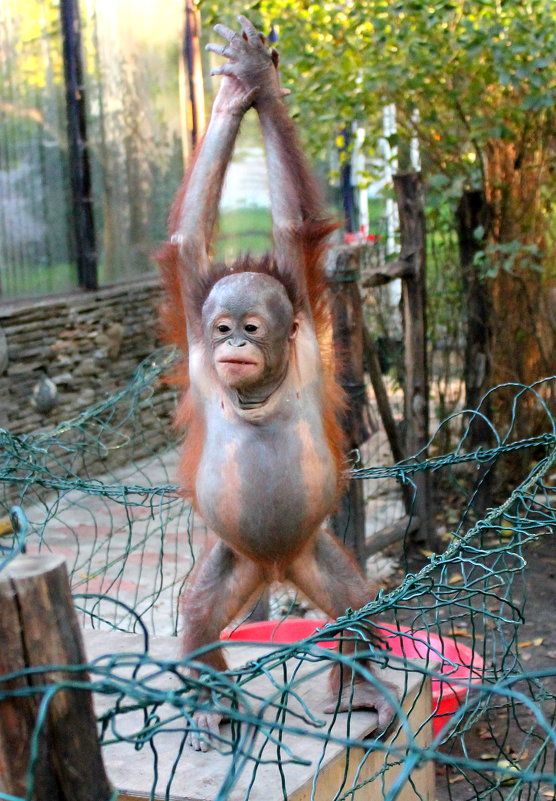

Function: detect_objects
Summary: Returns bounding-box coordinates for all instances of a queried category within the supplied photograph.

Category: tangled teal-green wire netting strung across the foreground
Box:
[0,351,556,801]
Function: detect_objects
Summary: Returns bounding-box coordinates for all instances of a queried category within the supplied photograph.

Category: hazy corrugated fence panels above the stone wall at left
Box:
[0,0,185,300]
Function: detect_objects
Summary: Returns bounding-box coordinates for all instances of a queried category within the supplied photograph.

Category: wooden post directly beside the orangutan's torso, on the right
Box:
[331,246,368,566]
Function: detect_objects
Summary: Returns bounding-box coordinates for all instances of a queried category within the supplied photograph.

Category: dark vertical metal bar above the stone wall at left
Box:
[60,0,98,289]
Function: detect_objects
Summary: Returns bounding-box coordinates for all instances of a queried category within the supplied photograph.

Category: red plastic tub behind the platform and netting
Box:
[220,618,483,735]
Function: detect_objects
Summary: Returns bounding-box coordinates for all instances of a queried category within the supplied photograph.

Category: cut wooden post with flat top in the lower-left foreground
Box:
[0,555,113,801]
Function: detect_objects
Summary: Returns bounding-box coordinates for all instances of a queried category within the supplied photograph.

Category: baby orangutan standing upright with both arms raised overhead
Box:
[155,17,392,750]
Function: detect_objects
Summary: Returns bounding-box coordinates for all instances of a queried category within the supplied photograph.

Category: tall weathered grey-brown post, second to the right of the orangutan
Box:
[394,172,434,548]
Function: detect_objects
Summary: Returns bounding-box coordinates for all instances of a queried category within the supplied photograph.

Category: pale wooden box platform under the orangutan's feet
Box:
[86,631,434,801]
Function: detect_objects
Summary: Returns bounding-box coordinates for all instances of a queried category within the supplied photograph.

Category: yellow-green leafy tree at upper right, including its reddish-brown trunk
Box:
[202,0,556,396]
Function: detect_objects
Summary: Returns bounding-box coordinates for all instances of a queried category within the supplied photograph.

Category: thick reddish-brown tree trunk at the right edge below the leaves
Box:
[485,140,556,437]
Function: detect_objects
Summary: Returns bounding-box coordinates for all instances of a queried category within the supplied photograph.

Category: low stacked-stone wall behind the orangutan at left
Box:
[0,276,174,434]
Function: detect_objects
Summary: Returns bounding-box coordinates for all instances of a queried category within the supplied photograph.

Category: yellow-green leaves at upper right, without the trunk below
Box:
[203,0,556,185]
